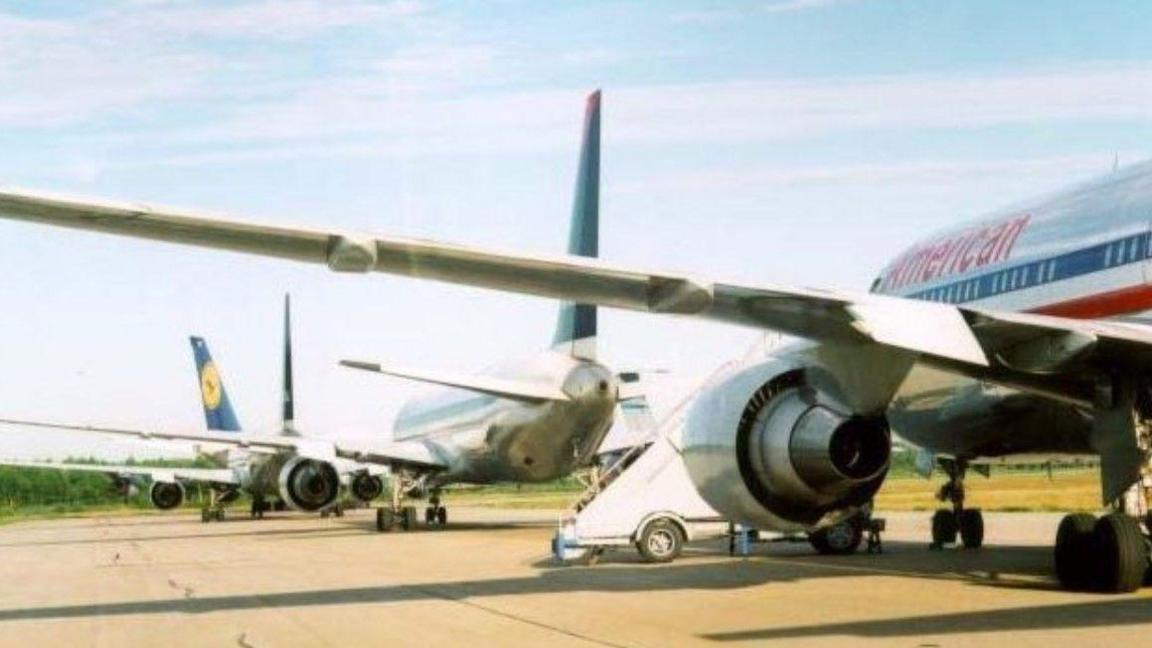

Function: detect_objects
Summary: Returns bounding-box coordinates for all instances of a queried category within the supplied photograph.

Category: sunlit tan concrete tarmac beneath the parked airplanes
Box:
[0,507,1152,648]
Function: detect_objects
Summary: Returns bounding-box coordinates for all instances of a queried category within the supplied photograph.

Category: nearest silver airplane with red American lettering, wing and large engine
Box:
[0,91,1152,592]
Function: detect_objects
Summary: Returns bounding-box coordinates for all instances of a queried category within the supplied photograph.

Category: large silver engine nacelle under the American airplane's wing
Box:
[682,357,892,530]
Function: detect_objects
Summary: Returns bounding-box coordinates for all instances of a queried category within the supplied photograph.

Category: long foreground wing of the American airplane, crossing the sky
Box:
[0,190,987,366]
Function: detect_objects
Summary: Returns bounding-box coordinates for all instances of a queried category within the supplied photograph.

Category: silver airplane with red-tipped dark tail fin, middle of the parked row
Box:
[2,95,641,532]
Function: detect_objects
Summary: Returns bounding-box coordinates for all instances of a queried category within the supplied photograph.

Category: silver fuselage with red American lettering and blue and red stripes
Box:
[873,159,1152,457]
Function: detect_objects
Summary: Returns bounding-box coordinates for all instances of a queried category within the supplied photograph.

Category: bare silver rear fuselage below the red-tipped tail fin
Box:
[393,352,617,484]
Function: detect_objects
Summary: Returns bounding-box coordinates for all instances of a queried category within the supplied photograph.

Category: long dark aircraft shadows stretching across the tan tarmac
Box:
[0,535,1152,642]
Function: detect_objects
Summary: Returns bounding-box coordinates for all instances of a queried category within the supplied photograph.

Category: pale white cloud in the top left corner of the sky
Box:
[0,0,433,127]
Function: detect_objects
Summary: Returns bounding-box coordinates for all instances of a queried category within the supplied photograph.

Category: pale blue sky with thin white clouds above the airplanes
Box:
[0,0,1152,457]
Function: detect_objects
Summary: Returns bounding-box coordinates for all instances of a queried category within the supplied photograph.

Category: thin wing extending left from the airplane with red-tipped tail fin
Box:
[0,419,447,468]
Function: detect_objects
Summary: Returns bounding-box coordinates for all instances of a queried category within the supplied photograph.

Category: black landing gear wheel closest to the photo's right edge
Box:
[1092,513,1147,594]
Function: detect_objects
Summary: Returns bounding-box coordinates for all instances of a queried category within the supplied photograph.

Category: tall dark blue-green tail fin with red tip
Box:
[552,90,600,360]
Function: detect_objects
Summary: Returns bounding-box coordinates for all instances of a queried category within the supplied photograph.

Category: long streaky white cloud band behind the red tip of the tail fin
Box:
[160,65,1152,155]
